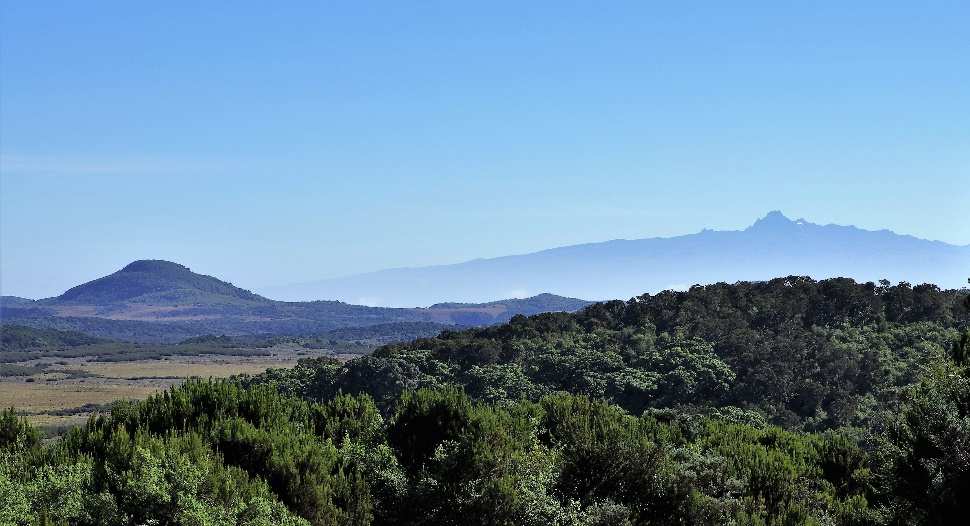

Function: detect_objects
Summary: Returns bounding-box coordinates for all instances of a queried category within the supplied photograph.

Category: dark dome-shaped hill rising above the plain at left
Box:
[57,260,269,305]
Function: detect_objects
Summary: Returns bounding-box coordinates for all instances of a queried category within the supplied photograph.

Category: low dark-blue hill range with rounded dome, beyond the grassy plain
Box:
[0,260,590,342]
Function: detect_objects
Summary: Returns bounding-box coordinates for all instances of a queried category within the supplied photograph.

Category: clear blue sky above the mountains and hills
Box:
[0,1,970,298]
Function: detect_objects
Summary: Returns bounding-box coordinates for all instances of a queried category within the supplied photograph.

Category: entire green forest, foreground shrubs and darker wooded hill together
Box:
[0,277,970,525]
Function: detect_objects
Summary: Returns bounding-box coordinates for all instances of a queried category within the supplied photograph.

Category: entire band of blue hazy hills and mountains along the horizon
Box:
[0,212,970,341]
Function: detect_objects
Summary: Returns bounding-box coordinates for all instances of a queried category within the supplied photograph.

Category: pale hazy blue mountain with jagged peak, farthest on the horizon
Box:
[264,211,970,305]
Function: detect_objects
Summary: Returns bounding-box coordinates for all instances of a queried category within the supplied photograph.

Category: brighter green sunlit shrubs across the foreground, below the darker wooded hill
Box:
[0,381,932,525]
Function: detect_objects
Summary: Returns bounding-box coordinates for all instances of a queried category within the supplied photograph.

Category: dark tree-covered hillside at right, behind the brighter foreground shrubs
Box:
[251,276,970,428]
